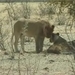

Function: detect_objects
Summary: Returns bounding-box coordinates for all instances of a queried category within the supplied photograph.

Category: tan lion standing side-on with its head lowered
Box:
[11,19,55,53]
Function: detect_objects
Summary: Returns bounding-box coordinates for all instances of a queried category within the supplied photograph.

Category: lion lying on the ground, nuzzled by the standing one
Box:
[47,33,74,54]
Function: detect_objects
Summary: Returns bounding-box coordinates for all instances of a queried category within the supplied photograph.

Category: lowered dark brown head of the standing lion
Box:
[43,25,55,38]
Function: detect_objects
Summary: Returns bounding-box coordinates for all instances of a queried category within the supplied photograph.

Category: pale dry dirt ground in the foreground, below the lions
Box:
[0,39,75,75]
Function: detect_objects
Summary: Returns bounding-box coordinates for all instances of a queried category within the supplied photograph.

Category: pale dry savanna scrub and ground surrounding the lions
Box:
[0,0,75,75]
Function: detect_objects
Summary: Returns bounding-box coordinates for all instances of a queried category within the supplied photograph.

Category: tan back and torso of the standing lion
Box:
[14,19,50,37]
